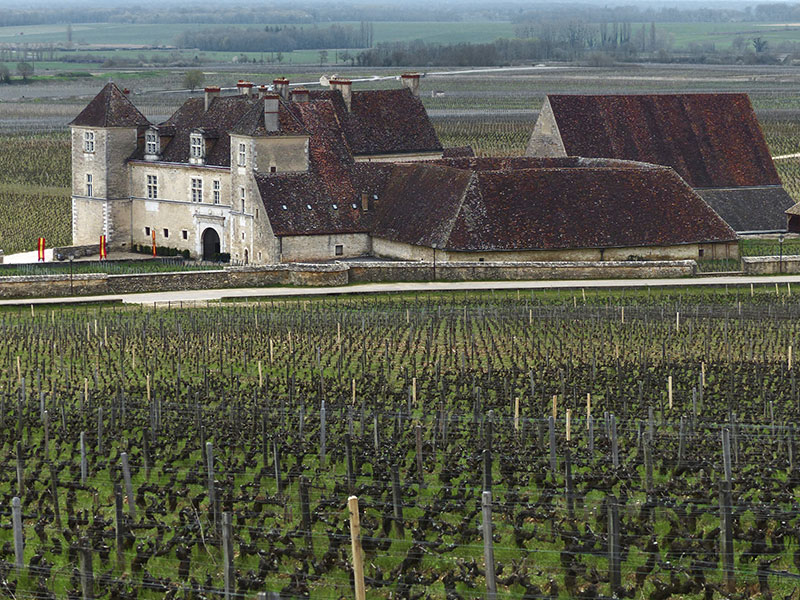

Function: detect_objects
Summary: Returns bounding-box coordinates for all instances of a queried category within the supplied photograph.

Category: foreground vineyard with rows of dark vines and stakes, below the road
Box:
[0,284,800,600]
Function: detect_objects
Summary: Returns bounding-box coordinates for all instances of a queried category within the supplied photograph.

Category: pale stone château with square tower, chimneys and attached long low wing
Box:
[71,80,738,264]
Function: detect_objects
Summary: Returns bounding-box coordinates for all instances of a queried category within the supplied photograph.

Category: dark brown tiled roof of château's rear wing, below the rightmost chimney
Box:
[310,88,442,155]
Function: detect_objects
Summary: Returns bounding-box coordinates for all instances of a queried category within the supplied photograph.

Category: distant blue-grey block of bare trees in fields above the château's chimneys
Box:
[175,22,373,52]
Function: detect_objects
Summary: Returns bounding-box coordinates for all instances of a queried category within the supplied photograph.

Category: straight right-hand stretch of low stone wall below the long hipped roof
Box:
[347,260,697,283]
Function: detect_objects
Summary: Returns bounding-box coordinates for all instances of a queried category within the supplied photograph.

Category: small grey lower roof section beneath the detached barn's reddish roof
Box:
[697,186,794,232]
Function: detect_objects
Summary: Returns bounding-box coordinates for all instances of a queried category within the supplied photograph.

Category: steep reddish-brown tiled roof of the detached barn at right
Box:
[548,94,781,188]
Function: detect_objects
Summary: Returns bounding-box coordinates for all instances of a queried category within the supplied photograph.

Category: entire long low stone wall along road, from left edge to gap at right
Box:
[0,260,696,298]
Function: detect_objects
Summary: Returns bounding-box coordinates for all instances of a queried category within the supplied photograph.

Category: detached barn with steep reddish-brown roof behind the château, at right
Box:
[527,94,794,233]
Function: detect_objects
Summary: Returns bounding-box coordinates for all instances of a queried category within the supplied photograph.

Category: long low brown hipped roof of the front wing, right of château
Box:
[372,159,736,251]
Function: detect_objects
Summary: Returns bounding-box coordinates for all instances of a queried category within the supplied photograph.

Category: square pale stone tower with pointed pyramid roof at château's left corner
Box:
[70,83,150,248]
